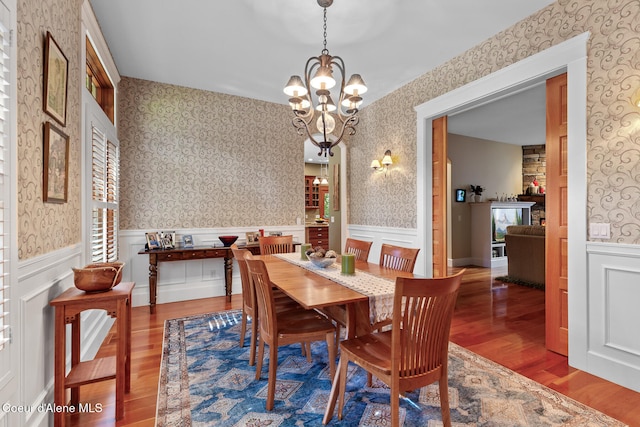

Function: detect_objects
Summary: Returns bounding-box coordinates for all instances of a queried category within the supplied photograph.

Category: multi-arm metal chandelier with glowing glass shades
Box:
[284,0,367,157]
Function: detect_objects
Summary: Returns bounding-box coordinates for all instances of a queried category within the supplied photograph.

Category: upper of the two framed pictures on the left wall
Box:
[43,31,69,126]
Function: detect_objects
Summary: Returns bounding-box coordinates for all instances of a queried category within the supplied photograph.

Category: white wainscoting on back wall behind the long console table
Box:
[118,225,305,307]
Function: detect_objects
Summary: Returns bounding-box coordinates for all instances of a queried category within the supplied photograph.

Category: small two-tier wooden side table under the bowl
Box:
[49,282,135,427]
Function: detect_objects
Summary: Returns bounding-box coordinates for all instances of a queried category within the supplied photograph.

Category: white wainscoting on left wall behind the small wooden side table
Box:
[11,245,114,426]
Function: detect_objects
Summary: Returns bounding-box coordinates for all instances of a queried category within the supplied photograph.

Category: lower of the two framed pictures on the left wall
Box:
[42,122,69,203]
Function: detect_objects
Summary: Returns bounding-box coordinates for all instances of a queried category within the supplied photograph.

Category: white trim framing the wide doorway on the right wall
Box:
[416,34,588,370]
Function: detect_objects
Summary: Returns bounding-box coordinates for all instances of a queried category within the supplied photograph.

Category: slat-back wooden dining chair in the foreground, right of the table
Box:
[326,270,464,427]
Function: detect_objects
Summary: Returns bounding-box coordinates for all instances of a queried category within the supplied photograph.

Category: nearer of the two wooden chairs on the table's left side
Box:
[247,258,336,411]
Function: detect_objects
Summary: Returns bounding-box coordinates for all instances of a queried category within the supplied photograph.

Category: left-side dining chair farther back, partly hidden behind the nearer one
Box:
[231,243,307,366]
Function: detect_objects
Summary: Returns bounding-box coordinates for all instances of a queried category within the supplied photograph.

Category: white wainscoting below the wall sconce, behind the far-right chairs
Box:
[347,224,424,276]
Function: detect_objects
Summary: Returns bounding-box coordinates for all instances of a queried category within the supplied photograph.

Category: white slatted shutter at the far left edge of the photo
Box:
[0,17,10,350]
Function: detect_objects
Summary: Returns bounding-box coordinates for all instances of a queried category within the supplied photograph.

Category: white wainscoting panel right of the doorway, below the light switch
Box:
[584,242,640,392]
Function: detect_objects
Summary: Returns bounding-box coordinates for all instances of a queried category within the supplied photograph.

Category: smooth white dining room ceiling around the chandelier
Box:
[90,0,554,161]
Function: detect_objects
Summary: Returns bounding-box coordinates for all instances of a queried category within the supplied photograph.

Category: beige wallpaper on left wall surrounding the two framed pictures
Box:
[16,0,84,259]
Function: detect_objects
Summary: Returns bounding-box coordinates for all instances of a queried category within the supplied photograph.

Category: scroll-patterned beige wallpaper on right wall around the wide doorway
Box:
[348,0,640,244]
